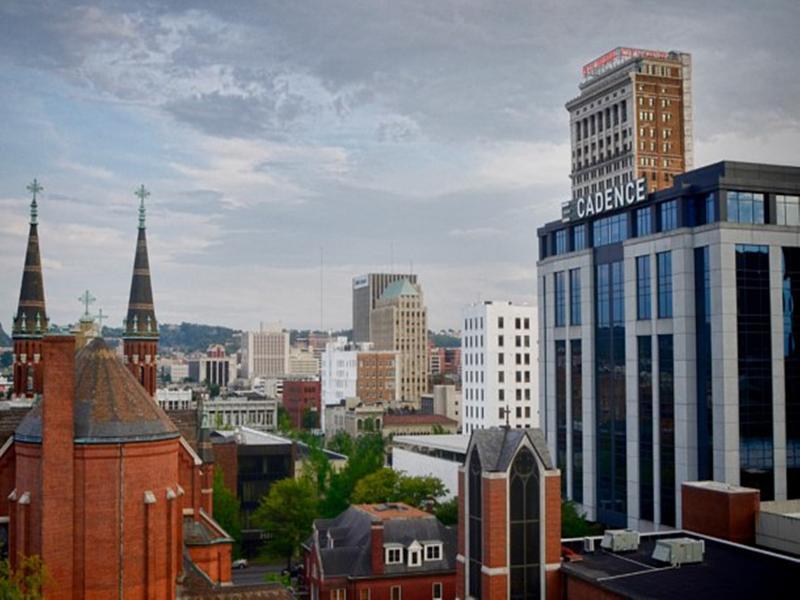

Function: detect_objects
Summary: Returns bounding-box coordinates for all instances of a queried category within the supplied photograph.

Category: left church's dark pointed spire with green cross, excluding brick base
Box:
[12,179,47,337]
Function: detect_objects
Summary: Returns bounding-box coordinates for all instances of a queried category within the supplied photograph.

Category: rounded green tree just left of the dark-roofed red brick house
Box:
[253,478,318,568]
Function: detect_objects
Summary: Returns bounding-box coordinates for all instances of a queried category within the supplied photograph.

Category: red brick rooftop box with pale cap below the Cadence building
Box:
[681,484,760,544]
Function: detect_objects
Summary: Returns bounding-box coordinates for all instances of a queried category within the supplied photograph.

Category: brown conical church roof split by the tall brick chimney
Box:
[14,338,180,444]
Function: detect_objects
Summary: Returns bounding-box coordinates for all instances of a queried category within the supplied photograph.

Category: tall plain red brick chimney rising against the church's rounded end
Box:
[41,335,75,598]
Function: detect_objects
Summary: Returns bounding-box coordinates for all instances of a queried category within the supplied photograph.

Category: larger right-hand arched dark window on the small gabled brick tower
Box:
[509,448,541,600]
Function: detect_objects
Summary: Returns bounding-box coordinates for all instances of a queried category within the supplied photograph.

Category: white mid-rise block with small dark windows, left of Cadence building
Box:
[461,300,539,433]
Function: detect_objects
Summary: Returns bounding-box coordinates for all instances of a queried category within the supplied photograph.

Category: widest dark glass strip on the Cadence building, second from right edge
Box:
[736,245,775,500]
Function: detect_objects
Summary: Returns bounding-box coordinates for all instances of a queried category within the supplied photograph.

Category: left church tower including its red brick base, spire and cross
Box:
[11,179,48,398]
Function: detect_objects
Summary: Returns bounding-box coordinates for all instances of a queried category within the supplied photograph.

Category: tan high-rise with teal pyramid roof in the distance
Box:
[370,279,430,406]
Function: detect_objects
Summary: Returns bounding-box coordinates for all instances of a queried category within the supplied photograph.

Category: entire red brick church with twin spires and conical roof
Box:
[0,181,232,599]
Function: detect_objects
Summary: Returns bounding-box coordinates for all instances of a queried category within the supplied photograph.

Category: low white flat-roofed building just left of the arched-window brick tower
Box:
[392,434,469,501]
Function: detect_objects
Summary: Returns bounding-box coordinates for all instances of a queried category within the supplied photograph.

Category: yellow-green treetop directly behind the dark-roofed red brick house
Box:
[352,467,447,508]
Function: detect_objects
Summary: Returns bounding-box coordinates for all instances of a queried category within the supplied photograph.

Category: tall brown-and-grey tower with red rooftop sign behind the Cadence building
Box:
[567,48,694,199]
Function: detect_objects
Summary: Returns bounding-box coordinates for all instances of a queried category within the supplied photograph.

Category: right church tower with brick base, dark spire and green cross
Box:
[122,186,158,397]
